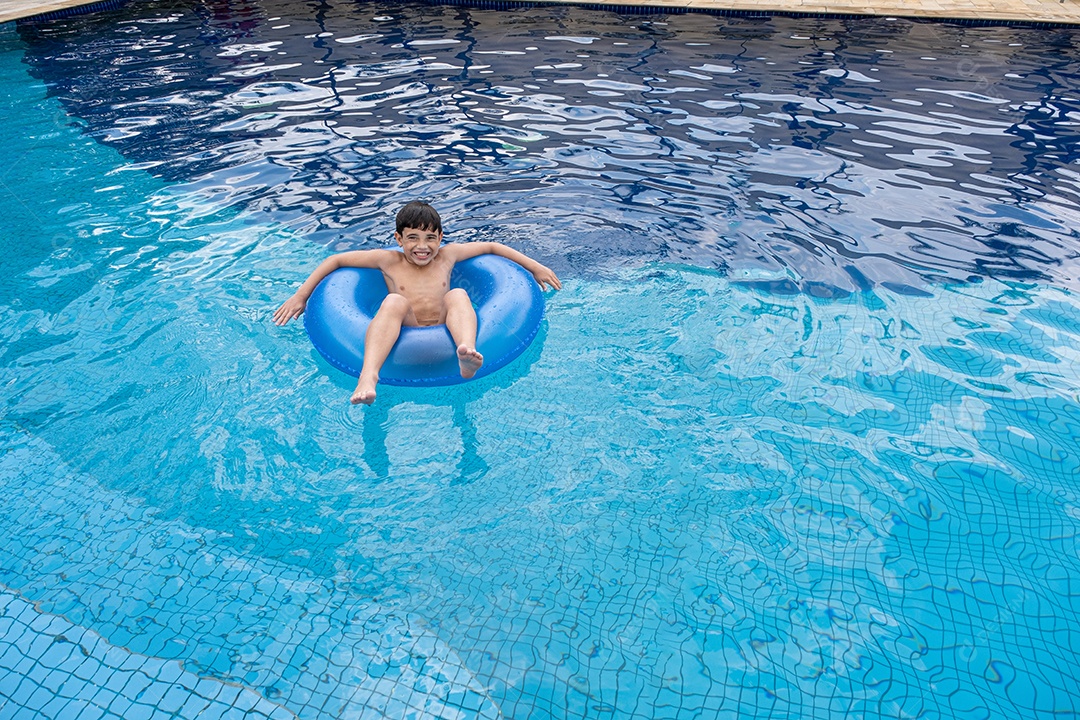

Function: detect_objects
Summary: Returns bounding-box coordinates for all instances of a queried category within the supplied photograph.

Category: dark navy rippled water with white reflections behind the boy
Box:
[14,1,1080,297]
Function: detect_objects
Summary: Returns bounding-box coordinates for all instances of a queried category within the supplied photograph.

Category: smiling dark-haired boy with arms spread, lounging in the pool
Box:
[273,201,563,405]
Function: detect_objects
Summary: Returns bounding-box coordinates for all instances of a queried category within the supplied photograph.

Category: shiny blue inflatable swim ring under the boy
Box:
[303,255,543,385]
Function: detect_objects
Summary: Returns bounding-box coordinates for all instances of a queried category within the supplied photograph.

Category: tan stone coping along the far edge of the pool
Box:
[6,0,1080,27]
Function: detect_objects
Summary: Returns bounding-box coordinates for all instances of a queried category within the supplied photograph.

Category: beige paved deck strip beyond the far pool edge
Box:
[0,0,1080,25]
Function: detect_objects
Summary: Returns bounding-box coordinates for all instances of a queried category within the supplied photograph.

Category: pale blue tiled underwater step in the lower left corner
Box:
[0,427,501,720]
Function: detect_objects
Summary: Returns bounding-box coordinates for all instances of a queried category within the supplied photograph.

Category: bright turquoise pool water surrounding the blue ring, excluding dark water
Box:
[0,10,1080,719]
